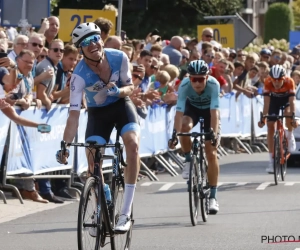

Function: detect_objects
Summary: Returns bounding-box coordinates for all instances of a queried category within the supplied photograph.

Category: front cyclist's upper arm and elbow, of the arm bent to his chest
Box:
[119,52,134,98]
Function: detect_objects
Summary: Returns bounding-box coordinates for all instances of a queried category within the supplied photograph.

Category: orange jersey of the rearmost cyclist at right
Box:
[264,77,295,97]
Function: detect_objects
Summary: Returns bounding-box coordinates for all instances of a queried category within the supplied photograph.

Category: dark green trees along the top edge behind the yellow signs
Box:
[53,0,242,39]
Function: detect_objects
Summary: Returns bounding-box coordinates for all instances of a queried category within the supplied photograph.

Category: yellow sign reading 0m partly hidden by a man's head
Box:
[197,24,235,48]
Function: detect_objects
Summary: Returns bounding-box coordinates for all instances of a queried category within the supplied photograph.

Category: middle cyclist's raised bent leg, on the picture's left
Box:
[179,100,200,179]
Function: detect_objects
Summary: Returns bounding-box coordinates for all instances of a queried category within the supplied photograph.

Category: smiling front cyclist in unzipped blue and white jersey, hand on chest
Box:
[57,23,140,236]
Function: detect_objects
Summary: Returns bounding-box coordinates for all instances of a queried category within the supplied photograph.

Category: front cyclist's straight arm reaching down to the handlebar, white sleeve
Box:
[63,74,85,143]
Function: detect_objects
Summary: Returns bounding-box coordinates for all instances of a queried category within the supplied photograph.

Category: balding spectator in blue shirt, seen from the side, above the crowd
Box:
[162,36,185,67]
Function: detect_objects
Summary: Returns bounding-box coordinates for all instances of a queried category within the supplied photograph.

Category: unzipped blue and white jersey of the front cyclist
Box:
[70,49,132,110]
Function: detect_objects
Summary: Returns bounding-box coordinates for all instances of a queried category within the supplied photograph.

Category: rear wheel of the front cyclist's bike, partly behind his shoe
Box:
[110,168,133,250]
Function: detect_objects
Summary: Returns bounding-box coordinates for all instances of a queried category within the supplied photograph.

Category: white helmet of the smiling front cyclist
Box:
[72,23,101,48]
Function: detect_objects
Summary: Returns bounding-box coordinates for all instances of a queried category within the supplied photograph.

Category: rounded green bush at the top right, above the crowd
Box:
[264,3,294,43]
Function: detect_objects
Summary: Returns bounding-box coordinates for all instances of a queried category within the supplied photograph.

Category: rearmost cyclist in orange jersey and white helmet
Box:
[258,64,297,174]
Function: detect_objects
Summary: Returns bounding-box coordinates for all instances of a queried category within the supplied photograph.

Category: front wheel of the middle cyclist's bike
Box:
[188,155,200,226]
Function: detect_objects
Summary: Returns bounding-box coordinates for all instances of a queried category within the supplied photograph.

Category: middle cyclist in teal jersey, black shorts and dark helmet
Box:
[169,60,220,214]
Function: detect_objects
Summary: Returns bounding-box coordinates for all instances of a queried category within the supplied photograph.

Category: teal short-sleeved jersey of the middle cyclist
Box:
[176,76,220,112]
